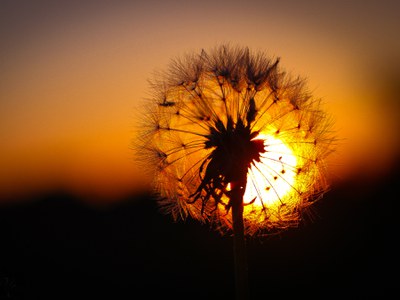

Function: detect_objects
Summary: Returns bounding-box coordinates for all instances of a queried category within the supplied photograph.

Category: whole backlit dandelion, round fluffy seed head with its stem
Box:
[136,45,333,298]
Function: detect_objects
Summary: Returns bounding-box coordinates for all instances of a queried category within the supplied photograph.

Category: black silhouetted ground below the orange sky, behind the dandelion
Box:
[0,162,400,300]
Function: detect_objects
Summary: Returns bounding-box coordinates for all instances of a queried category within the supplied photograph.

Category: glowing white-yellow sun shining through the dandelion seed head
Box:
[243,134,297,214]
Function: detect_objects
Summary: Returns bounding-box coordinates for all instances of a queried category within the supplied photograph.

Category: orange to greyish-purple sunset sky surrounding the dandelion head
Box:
[0,0,400,202]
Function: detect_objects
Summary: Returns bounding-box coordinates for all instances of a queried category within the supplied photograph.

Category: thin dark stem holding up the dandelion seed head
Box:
[231,180,248,300]
